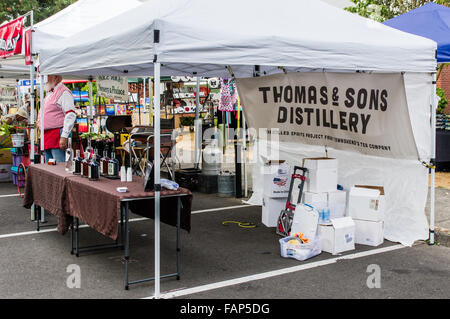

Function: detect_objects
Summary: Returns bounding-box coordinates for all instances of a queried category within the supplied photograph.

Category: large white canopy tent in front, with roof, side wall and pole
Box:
[40,0,436,297]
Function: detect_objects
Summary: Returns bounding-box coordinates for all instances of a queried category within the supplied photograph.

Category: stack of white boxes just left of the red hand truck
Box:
[262,161,292,227]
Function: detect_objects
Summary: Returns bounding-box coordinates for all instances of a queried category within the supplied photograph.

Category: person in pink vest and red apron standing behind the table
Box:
[38,75,77,162]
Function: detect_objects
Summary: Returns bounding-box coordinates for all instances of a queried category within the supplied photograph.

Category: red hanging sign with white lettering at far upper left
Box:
[0,17,23,58]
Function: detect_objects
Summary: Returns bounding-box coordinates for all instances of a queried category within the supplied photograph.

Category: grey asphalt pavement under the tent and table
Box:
[0,184,450,299]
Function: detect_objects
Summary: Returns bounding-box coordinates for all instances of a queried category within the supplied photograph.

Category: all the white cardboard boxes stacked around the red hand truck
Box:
[262,157,385,255]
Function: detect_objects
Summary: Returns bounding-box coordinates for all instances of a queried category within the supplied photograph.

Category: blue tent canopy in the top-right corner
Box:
[384,2,450,63]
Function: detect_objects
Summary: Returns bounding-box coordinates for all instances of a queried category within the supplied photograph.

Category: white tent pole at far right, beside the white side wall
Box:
[429,73,437,245]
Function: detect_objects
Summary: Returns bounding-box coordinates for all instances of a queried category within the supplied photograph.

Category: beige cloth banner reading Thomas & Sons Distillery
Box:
[237,72,420,159]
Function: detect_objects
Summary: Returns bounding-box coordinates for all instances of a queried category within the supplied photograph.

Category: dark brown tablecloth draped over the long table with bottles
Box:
[24,164,192,239]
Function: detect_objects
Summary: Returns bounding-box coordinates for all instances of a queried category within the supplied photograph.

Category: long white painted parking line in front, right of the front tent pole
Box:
[147,244,405,299]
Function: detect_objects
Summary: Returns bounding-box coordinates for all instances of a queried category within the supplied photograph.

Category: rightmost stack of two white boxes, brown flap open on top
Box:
[349,185,385,246]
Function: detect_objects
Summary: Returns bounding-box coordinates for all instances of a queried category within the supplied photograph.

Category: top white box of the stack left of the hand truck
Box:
[264,161,292,198]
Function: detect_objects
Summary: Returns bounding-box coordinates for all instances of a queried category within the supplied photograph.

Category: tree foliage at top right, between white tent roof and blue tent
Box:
[347,0,450,22]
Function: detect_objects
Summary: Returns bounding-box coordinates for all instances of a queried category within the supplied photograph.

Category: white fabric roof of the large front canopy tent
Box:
[40,0,436,76]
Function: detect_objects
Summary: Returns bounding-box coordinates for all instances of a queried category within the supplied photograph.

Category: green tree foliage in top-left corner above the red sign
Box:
[0,0,76,23]
